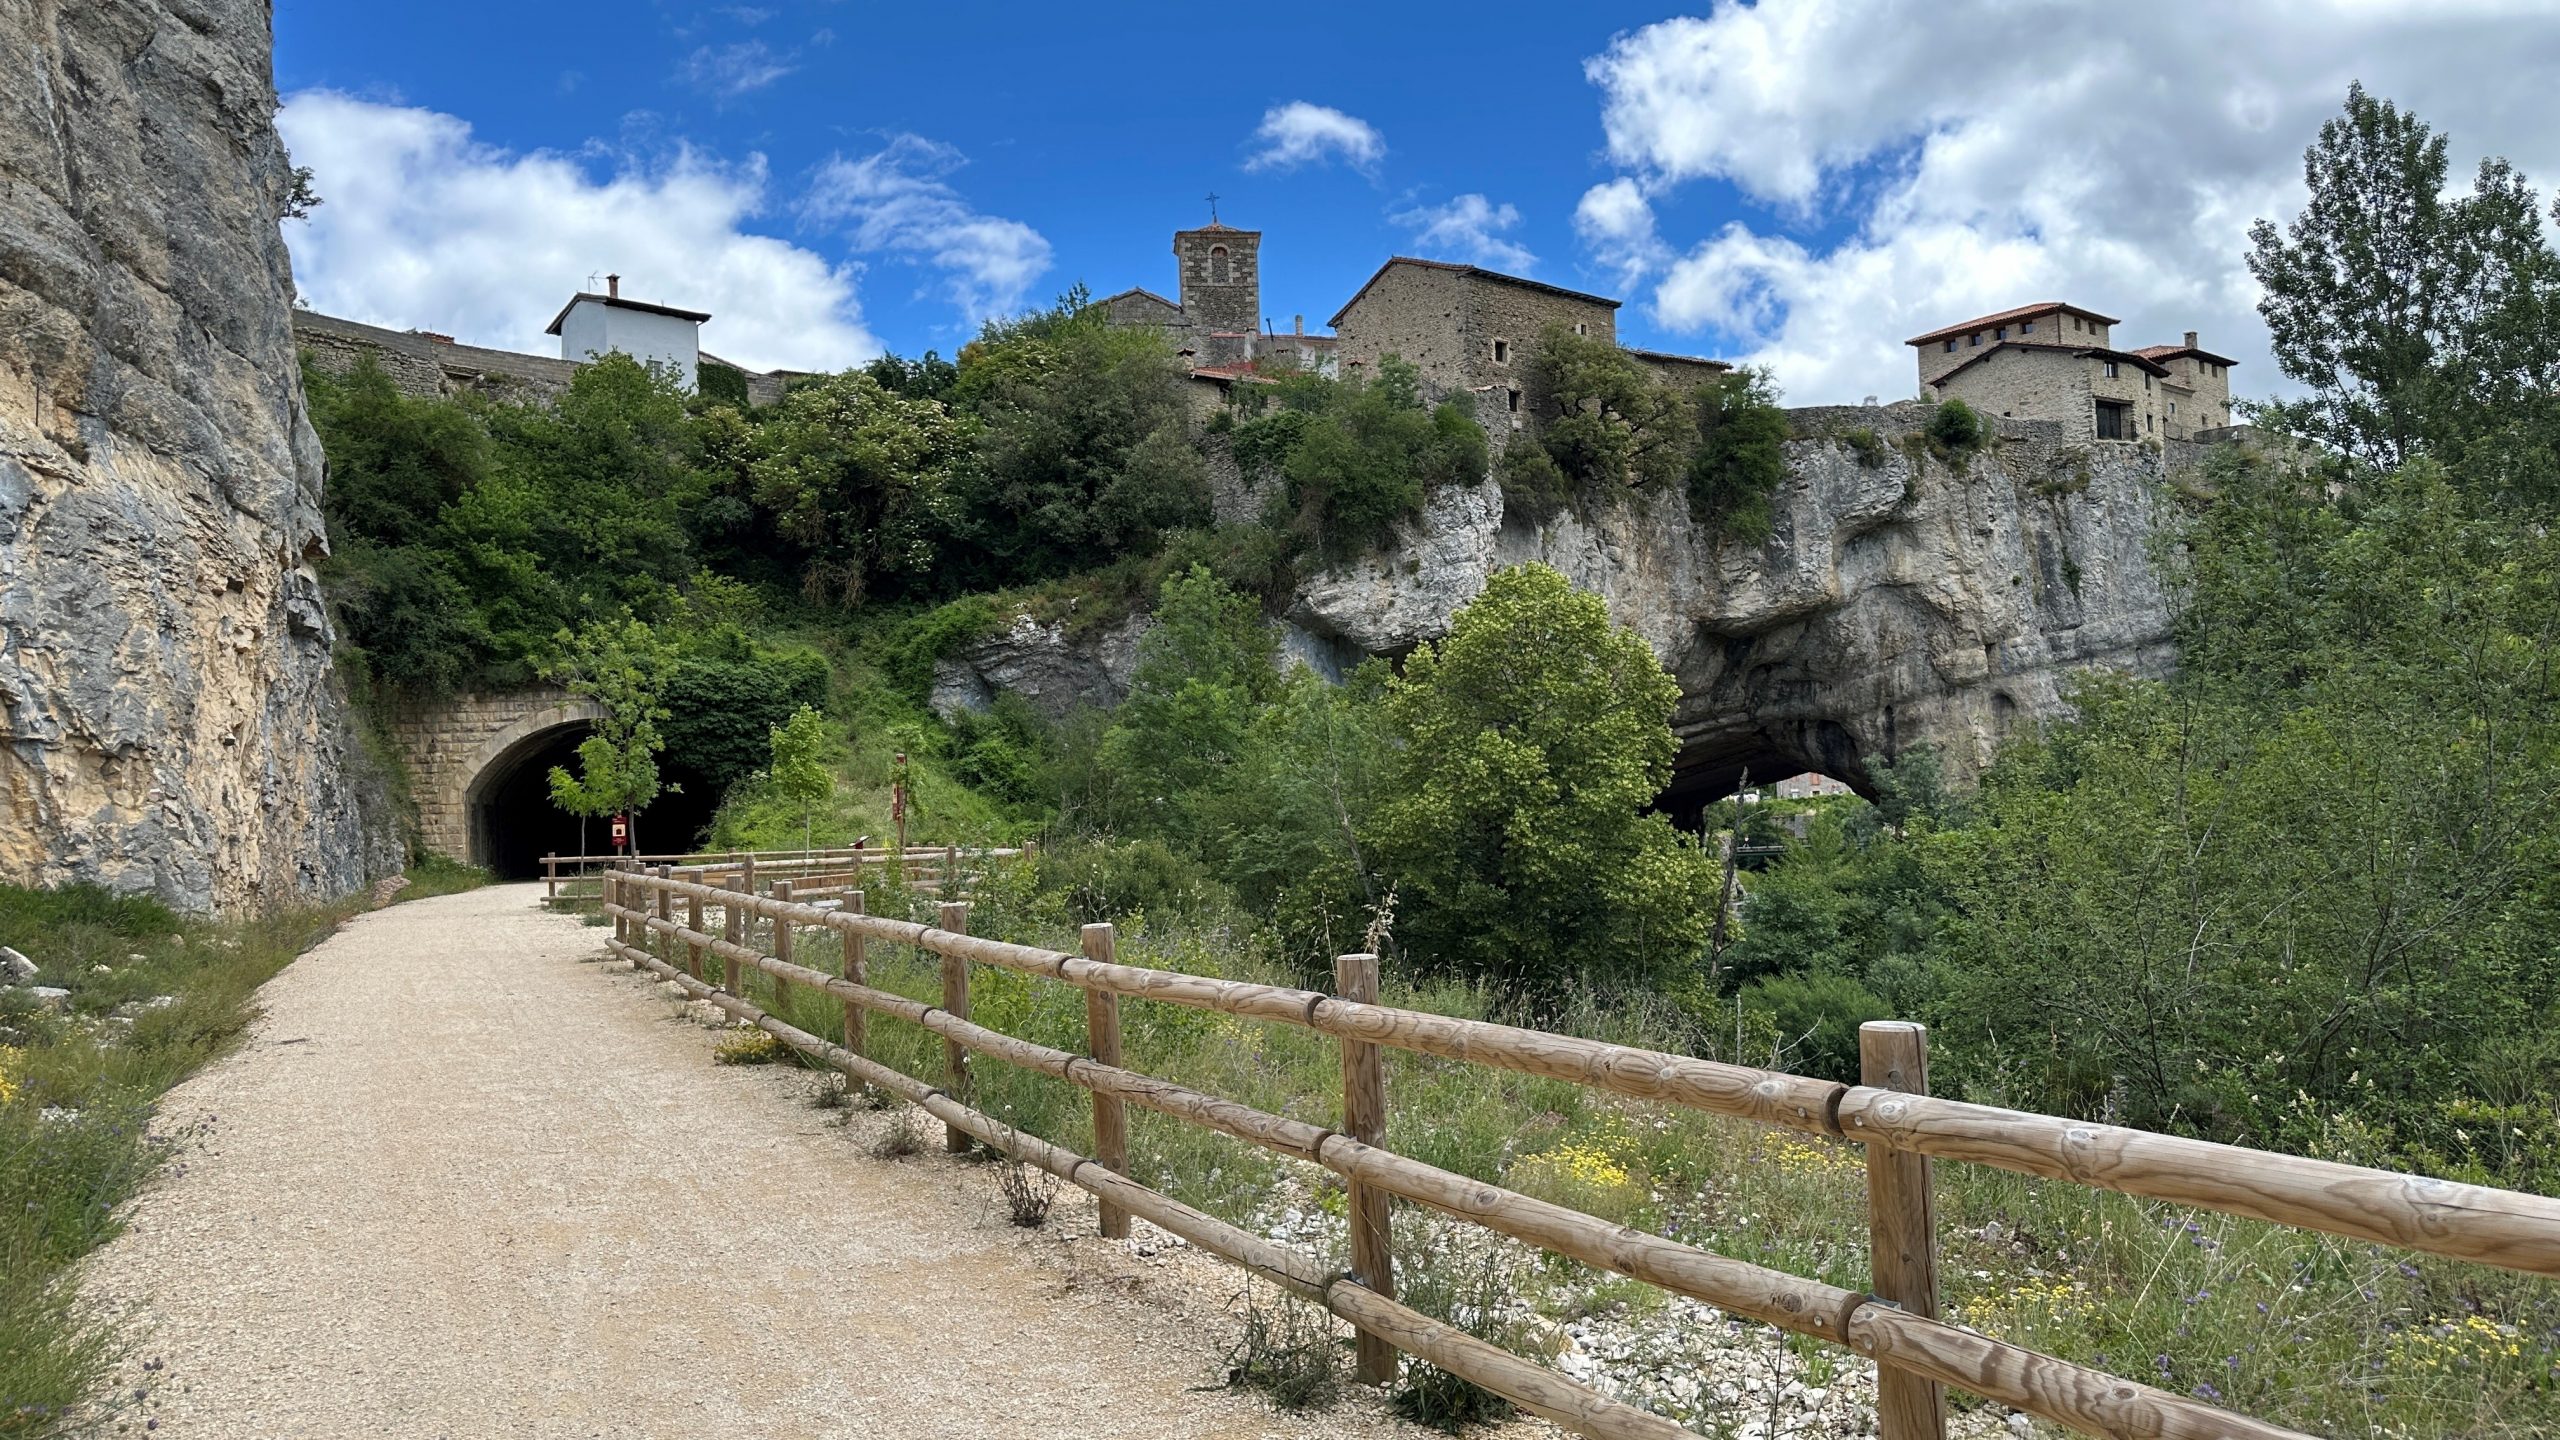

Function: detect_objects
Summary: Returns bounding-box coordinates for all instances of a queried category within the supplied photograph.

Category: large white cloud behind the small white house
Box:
[276,90,881,369]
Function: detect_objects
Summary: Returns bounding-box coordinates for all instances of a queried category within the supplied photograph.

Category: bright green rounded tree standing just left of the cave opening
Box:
[1370,564,1715,999]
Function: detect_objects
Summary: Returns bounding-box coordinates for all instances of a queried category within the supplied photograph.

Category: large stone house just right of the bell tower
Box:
[1331,256,1733,438]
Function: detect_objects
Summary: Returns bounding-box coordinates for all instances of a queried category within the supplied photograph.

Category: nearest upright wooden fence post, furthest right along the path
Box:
[1859,1020,1946,1440]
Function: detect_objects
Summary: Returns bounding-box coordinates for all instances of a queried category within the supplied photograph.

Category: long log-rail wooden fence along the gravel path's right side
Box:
[604,869,2560,1440]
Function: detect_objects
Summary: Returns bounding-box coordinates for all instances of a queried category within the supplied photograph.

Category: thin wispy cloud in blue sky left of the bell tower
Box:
[801,136,1050,320]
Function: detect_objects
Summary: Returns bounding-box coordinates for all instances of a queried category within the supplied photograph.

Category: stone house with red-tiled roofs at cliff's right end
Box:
[1905,300,2235,443]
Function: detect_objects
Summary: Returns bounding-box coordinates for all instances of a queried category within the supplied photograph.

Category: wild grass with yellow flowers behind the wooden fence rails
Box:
[645,855,2560,1440]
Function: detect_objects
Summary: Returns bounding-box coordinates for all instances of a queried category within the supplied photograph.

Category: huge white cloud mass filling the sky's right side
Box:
[1574,0,2560,402]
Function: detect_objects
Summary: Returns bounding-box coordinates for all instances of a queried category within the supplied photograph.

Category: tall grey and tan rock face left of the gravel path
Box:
[0,0,397,910]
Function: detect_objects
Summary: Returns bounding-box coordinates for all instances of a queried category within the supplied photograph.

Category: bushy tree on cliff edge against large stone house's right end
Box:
[1528,325,1697,489]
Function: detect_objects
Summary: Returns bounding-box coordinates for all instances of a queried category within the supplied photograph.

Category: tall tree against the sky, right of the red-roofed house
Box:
[2248,85,2560,500]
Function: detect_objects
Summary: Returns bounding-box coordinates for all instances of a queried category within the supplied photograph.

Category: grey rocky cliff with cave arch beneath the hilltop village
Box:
[937,405,2194,802]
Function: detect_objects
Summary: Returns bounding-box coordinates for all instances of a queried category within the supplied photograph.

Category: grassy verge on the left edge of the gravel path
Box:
[0,887,361,1435]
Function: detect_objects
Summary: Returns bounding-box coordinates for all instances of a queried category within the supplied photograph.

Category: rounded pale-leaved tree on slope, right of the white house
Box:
[748,372,963,607]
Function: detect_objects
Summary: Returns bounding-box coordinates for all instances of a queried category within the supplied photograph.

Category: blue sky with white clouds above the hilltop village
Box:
[276,0,2560,402]
